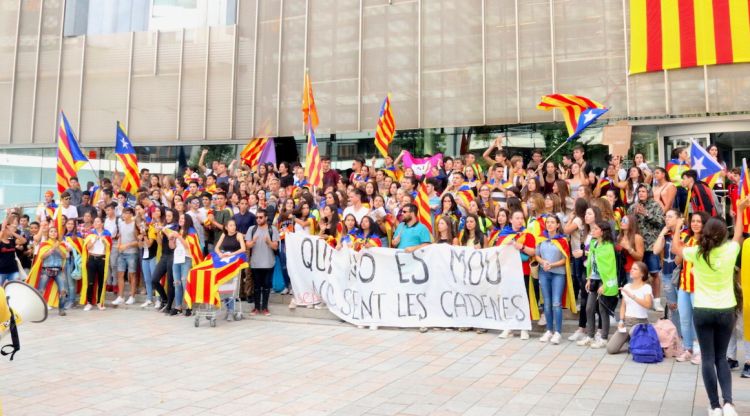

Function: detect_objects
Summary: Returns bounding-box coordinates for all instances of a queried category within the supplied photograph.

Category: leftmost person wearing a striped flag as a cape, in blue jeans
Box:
[26,227,68,316]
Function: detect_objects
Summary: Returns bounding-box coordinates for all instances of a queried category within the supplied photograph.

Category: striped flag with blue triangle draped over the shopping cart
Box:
[184,253,248,308]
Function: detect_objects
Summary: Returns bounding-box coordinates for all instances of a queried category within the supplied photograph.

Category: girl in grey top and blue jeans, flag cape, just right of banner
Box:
[535,215,576,345]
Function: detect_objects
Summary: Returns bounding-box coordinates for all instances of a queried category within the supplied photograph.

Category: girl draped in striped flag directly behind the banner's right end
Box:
[495,211,539,340]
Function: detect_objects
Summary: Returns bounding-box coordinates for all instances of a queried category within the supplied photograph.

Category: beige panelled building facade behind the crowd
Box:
[0,0,750,205]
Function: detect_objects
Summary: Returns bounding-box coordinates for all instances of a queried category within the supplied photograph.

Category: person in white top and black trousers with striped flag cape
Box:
[81,217,112,311]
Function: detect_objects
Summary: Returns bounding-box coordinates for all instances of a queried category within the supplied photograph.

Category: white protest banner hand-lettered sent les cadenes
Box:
[286,233,531,330]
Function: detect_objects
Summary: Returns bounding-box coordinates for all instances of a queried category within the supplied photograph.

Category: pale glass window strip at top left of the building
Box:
[64,0,237,36]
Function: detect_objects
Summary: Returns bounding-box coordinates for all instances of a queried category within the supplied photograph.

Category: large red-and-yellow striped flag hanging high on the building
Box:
[630,0,750,74]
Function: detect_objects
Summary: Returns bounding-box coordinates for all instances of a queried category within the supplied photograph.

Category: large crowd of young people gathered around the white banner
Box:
[0,138,750,414]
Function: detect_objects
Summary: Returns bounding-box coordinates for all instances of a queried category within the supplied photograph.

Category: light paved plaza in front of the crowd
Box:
[0,305,750,416]
